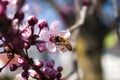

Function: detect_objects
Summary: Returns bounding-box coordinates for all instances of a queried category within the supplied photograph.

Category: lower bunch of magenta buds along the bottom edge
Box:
[14,57,63,80]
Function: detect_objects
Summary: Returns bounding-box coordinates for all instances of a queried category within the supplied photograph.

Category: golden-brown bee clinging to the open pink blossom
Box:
[54,36,72,51]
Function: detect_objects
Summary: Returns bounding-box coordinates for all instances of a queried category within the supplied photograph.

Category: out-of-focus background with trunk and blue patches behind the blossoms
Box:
[0,0,120,80]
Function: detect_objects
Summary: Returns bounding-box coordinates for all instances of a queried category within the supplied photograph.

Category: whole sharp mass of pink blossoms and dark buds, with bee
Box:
[0,0,72,80]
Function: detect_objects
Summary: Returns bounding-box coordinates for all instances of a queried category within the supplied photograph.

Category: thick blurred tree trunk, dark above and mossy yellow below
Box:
[76,3,110,80]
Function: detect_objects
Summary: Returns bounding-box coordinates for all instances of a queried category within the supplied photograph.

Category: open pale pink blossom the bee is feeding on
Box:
[40,21,70,52]
